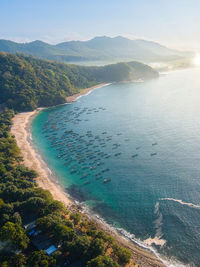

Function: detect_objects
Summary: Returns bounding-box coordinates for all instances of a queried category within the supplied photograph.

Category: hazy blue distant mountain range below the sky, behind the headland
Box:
[0,36,193,63]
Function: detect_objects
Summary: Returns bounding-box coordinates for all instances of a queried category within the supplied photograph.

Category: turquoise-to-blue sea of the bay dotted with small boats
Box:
[32,68,200,266]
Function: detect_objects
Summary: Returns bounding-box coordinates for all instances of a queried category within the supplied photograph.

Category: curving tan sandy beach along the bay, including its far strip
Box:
[11,84,167,267]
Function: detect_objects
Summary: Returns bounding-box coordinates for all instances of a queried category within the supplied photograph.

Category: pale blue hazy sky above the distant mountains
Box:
[0,0,200,51]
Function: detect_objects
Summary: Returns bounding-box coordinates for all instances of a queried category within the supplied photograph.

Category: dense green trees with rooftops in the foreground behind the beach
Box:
[0,110,134,267]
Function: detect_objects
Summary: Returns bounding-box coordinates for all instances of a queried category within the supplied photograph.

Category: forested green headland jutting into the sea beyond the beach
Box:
[0,52,158,111]
